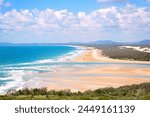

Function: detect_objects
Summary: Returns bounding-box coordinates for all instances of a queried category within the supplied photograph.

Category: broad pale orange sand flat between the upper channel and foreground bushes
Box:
[36,65,150,92]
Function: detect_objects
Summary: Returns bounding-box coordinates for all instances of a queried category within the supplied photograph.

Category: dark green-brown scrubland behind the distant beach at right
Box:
[79,44,150,61]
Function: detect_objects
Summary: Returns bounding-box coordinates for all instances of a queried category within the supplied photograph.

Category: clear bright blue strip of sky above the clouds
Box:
[3,0,150,12]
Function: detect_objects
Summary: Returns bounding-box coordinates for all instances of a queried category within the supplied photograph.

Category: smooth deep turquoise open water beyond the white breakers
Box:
[0,46,75,65]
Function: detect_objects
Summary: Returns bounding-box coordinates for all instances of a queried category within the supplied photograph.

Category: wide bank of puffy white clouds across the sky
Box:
[0,5,150,41]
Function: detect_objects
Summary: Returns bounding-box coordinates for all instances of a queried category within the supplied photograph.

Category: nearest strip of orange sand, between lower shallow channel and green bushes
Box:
[48,77,150,92]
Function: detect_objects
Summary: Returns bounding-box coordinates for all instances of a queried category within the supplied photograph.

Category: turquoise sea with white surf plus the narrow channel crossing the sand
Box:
[0,46,150,94]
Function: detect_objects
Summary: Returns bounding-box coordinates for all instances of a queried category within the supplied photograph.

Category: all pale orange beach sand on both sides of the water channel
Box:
[34,47,150,91]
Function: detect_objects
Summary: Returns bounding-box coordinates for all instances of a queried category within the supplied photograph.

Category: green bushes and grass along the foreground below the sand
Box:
[0,83,150,100]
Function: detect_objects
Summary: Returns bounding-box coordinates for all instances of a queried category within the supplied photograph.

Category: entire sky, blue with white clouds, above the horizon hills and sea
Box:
[0,0,150,43]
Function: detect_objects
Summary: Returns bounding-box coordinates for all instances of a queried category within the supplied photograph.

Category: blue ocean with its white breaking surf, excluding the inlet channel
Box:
[0,45,82,94]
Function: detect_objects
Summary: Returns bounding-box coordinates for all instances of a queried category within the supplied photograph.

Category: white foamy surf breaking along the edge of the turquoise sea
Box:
[0,46,84,94]
